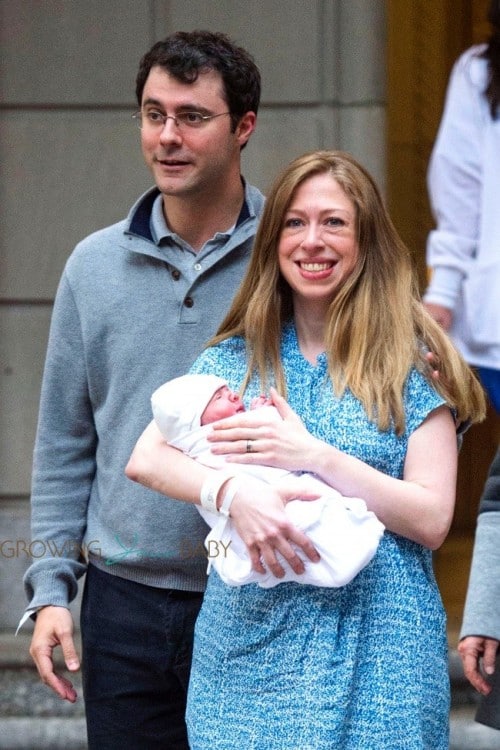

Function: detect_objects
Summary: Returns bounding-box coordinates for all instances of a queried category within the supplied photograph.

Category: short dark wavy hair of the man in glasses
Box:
[135,31,260,131]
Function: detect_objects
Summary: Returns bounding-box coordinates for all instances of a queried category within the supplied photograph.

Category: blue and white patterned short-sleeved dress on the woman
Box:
[187,325,449,750]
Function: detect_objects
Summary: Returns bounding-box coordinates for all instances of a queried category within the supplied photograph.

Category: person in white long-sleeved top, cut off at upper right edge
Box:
[424,8,500,411]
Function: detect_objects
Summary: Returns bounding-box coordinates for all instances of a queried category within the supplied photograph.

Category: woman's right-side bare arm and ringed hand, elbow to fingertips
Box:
[210,392,457,549]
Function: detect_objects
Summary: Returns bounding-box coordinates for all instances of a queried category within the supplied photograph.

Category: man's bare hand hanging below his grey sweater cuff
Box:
[30,606,80,703]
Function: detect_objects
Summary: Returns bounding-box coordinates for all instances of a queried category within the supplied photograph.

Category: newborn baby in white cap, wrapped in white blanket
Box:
[151,374,385,588]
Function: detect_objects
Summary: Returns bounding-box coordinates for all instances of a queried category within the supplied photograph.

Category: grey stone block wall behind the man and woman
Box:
[0,0,385,630]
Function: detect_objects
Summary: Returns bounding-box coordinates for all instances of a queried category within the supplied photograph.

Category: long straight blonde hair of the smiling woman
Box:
[209,151,485,434]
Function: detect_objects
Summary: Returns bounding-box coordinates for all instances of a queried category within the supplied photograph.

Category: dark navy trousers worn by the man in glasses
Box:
[81,565,203,750]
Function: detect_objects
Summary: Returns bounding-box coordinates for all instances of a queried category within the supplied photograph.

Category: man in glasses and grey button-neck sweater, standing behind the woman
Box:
[25,31,264,750]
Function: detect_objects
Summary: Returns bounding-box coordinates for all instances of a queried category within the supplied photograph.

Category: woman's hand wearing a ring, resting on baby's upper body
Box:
[208,388,321,471]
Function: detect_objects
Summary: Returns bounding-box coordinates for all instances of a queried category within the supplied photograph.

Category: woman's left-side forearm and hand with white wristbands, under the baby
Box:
[125,422,319,578]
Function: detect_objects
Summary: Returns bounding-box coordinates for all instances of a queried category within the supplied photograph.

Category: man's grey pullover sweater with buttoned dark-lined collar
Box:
[25,186,264,608]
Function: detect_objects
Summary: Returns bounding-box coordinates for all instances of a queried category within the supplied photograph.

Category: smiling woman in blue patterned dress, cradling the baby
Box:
[128,151,484,750]
